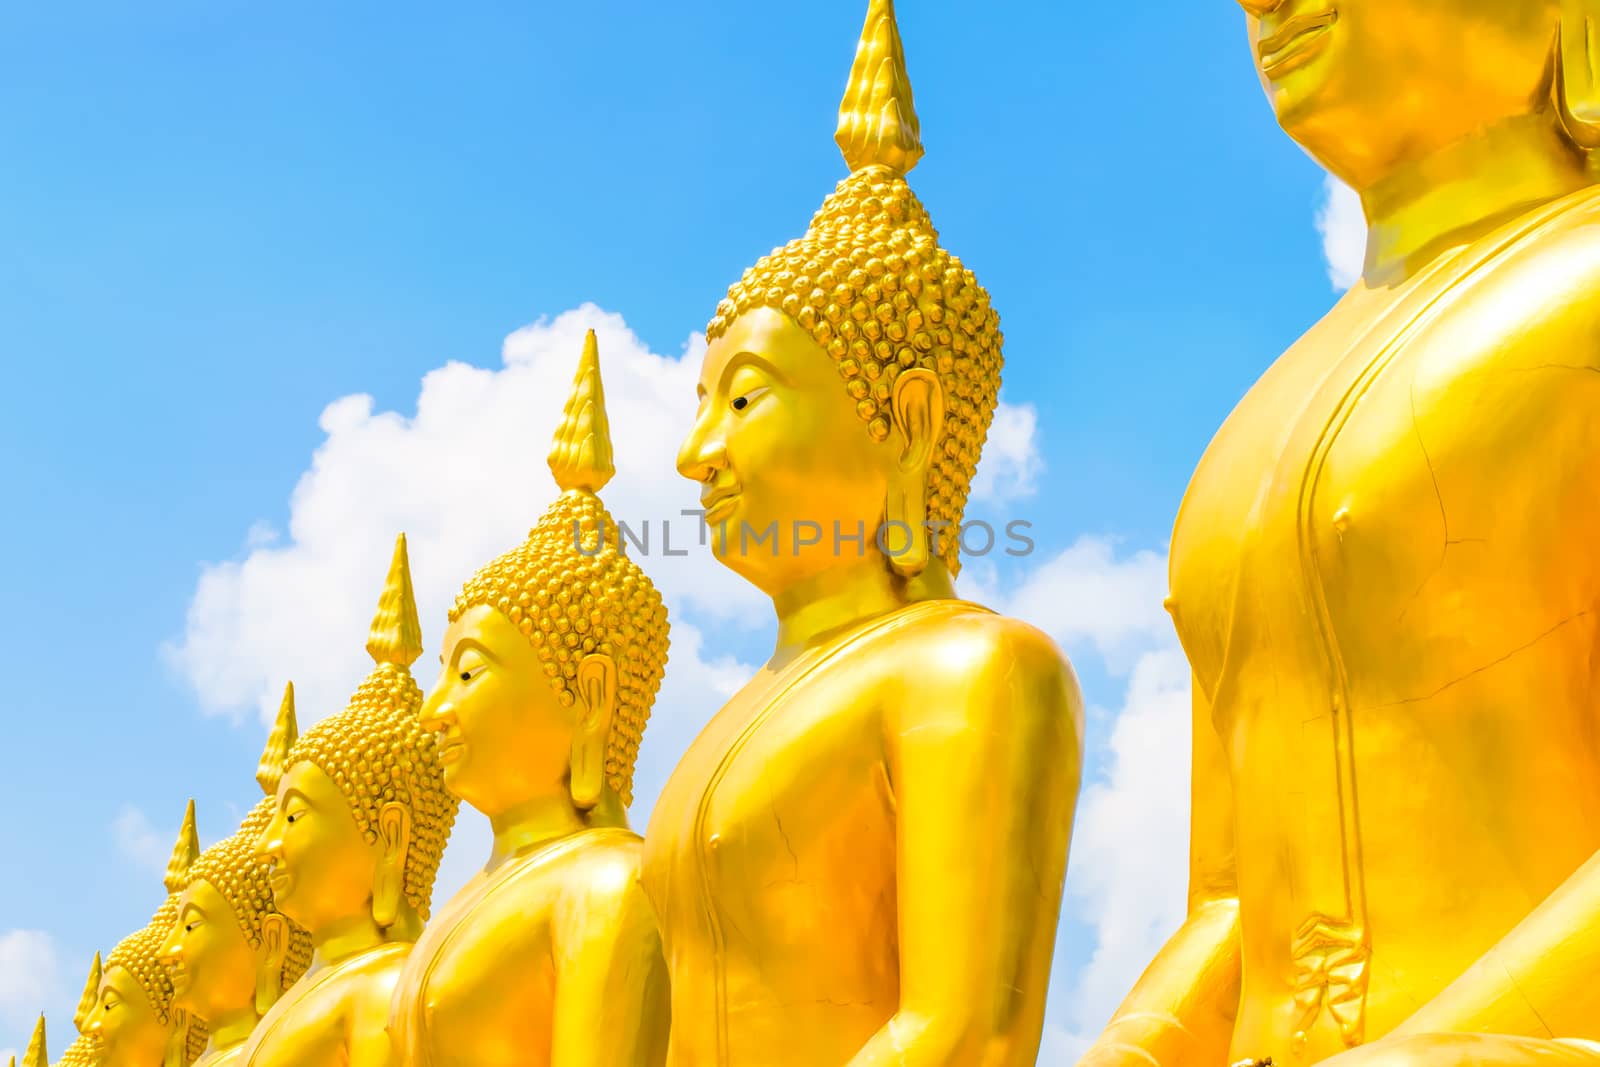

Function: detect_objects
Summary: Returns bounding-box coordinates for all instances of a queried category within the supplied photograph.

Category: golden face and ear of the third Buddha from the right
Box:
[422,605,618,817]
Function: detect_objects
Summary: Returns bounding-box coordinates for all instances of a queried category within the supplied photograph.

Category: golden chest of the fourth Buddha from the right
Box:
[240,942,411,1067]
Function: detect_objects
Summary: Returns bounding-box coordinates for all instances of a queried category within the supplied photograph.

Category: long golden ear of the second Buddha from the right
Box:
[883,366,944,577]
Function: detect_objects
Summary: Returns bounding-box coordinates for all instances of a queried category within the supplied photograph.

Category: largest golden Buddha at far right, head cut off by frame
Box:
[1083,0,1600,1067]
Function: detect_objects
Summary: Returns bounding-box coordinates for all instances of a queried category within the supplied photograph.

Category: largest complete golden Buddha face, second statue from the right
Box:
[678,307,939,597]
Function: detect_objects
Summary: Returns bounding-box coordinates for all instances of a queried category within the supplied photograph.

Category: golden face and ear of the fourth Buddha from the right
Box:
[256,760,410,934]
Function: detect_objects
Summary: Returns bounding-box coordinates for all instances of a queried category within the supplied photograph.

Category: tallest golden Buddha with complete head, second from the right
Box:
[643,0,1083,1067]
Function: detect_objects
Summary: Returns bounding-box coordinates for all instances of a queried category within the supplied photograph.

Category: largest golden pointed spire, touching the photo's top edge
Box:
[834,0,922,178]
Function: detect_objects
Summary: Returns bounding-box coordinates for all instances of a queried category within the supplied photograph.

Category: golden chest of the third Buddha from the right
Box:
[390,829,654,1067]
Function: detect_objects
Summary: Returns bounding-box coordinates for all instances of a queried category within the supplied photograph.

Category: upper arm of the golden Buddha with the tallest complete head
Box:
[850,616,1083,1067]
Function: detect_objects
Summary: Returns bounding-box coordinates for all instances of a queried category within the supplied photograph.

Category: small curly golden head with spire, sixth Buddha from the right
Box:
[78,800,206,1067]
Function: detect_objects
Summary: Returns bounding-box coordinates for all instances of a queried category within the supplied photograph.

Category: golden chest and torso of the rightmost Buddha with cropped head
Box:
[1170,194,1600,1064]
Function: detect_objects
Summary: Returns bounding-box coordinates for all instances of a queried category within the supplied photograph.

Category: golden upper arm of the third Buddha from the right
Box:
[549,849,672,1067]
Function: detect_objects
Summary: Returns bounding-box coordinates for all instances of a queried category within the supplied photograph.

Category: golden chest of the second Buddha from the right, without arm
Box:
[643,601,981,1067]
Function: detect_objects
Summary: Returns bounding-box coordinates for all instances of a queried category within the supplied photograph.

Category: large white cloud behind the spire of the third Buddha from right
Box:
[168,304,768,723]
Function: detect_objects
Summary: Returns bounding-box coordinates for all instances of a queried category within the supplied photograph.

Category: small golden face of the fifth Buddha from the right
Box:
[157,881,256,1019]
